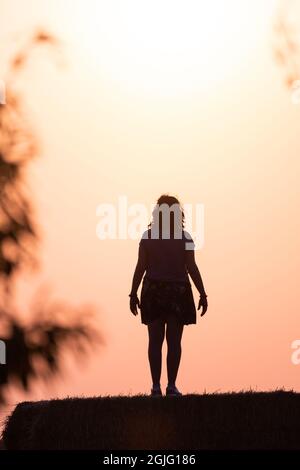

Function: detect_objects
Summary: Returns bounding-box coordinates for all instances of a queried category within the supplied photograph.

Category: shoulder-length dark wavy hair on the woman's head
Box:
[148,194,185,238]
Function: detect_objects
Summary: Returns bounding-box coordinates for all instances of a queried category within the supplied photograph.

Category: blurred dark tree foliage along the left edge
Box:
[0,30,103,402]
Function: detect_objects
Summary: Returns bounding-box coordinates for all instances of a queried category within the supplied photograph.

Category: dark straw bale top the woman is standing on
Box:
[3,391,300,450]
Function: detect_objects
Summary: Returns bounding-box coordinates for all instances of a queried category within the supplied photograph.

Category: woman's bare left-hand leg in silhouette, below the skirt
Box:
[148,320,165,387]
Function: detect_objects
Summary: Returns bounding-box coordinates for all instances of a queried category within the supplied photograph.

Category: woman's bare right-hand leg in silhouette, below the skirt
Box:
[166,317,184,387]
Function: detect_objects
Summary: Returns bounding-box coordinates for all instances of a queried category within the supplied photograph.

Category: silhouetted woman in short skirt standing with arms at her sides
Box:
[129,195,207,396]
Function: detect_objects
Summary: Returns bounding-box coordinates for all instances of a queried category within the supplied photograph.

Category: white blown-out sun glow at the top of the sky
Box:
[72,0,272,94]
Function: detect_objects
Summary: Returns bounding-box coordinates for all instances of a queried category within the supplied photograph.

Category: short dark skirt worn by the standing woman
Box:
[141,278,196,325]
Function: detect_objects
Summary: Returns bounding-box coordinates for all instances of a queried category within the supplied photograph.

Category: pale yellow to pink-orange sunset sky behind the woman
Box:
[0,0,300,408]
